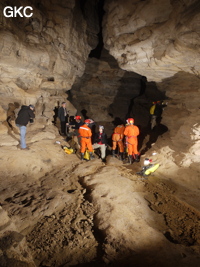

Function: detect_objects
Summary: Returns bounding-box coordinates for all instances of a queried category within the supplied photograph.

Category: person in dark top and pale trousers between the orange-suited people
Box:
[93,125,107,161]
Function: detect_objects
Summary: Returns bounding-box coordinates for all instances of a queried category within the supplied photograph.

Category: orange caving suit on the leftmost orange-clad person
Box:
[78,124,93,153]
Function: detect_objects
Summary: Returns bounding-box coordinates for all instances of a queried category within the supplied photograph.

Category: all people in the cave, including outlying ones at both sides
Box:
[16,101,166,163]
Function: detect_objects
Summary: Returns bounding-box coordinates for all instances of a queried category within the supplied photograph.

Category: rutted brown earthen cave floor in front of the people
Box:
[0,126,200,267]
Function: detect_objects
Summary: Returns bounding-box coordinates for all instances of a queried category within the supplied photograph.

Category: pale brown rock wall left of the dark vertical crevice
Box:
[0,0,99,133]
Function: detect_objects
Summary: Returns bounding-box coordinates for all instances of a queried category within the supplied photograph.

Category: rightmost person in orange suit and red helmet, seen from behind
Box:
[124,118,139,164]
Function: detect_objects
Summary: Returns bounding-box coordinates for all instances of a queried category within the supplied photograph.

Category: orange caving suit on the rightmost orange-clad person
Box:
[124,125,140,156]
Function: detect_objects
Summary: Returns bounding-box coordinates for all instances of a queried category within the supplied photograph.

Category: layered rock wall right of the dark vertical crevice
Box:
[103,0,200,188]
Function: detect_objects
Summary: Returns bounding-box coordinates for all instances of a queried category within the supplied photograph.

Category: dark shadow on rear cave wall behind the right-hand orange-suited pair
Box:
[108,73,168,154]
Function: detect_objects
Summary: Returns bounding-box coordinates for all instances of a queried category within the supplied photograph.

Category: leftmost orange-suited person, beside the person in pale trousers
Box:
[79,119,94,160]
